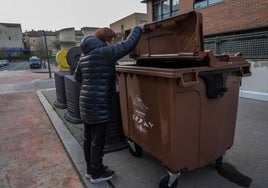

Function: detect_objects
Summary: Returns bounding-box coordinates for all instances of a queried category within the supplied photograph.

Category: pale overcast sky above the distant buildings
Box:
[0,0,146,32]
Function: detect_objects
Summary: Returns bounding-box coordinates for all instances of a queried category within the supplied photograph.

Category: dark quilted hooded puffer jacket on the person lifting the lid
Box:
[74,26,142,124]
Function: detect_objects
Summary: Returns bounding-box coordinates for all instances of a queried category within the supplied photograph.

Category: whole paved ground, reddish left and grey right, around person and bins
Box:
[0,70,268,188]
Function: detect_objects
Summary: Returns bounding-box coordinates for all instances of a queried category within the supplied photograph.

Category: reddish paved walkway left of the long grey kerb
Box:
[0,71,84,188]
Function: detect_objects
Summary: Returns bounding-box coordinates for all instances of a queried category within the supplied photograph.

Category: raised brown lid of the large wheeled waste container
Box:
[126,11,204,60]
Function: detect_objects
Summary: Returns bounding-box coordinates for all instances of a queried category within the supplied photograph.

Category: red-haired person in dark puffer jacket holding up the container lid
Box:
[74,26,143,183]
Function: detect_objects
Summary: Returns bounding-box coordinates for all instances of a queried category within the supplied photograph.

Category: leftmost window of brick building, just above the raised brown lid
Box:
[153,0,179,21]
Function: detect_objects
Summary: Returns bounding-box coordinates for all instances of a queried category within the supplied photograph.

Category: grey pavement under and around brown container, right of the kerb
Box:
[41,89,268,188]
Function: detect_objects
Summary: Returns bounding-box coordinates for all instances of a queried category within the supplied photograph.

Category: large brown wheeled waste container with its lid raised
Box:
[116,12,250,187]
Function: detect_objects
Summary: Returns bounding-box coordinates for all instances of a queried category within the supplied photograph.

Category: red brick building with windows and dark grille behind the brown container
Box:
[142,0,268,58]
